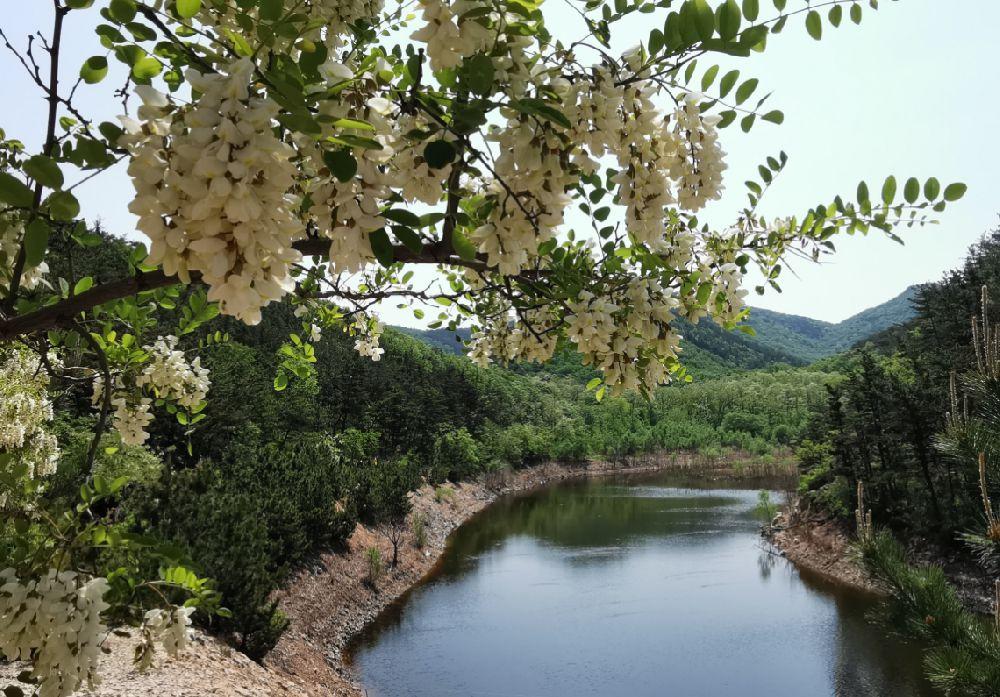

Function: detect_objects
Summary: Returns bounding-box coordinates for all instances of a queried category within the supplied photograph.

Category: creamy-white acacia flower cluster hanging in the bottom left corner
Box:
[0,569,109,697]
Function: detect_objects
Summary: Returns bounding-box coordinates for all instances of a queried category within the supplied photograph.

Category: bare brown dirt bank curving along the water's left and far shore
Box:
[0,453,788,697]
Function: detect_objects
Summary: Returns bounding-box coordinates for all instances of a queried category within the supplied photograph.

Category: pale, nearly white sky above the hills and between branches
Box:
[0,0,1000,324]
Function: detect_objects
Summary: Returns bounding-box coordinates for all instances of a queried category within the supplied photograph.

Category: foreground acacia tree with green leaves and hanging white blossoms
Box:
[0,0,965,695]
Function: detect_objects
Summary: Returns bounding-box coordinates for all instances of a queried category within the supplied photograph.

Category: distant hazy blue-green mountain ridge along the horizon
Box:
[396,285,920,375]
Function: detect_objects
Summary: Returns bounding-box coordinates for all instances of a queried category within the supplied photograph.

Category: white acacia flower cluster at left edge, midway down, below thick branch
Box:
[0,349,59,478]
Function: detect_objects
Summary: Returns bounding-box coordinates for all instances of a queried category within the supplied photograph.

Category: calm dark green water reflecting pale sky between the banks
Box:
[351,476,934,697]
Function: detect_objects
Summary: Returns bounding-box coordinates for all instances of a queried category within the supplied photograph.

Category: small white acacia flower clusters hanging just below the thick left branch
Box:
[91,336,212,445]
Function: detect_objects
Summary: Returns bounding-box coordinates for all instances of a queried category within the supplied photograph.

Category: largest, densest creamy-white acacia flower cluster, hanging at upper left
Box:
[122,59,302,324]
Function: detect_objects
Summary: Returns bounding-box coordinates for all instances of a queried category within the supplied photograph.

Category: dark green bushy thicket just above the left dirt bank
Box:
[126,426,356,658]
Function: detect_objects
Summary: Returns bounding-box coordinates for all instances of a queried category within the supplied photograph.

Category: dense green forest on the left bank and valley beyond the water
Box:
[7,233,831,658]
